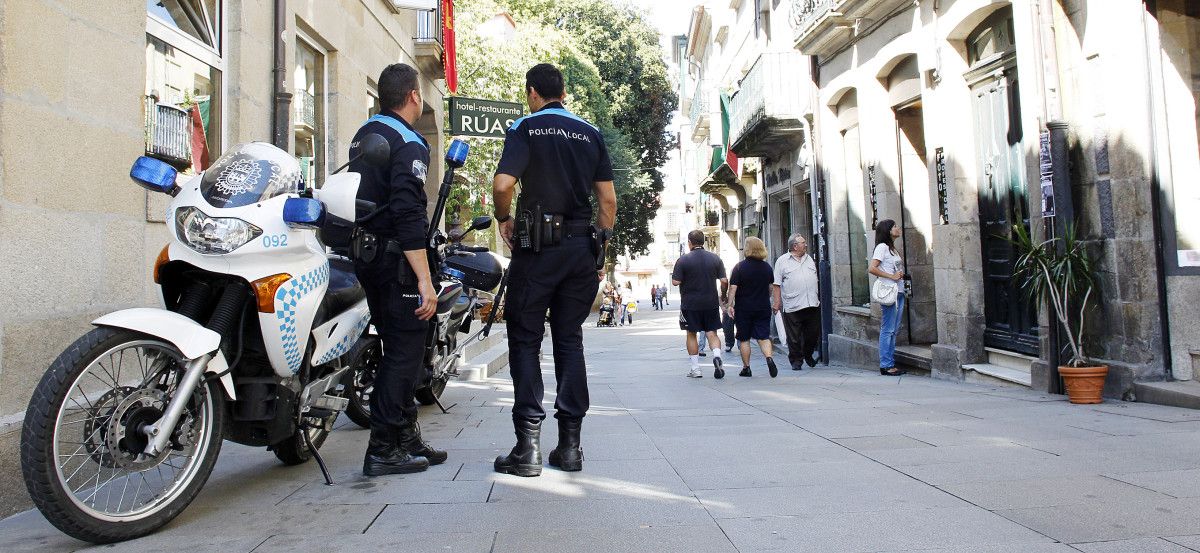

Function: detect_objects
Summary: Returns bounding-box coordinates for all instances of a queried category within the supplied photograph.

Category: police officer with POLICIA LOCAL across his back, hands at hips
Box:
[493,64,617,476]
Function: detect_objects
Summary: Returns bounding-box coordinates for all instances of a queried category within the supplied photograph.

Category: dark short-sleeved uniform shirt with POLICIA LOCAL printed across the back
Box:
[496,102,612,221]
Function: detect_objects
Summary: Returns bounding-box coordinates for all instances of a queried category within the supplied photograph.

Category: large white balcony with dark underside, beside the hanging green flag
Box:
[730,50,812,157]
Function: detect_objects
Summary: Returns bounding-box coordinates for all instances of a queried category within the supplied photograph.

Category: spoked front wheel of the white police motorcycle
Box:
[20,329,224,543]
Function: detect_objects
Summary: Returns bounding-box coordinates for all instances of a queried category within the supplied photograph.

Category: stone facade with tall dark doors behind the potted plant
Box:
[792,0,1200,398]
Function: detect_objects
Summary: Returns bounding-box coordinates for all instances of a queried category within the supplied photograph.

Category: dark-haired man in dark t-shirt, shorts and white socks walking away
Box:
[671,230,730,378]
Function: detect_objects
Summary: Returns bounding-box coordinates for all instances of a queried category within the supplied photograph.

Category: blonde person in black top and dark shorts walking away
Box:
[730,236,779,378]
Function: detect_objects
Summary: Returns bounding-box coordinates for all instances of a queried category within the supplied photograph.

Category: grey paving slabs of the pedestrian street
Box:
[0,309,1200,553]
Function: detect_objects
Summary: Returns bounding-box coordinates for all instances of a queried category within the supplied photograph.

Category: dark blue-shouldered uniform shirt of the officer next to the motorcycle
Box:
[350,110,430,251]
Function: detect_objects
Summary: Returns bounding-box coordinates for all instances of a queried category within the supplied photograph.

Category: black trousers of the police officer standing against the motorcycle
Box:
[354,254,430,428]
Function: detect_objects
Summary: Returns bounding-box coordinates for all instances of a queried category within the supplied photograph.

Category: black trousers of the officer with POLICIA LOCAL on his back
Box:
[504,238,600,420]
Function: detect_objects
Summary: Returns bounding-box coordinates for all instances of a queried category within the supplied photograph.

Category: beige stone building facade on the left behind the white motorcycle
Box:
[0,0,444,516]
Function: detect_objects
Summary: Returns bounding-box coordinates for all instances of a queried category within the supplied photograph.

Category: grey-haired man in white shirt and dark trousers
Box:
[770,234,821,371]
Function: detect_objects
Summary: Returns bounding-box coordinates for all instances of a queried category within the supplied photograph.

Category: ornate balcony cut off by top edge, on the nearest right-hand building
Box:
[791,0,914,56]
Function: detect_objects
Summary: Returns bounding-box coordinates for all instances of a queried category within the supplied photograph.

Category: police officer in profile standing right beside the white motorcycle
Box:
[350,64,446,476]
